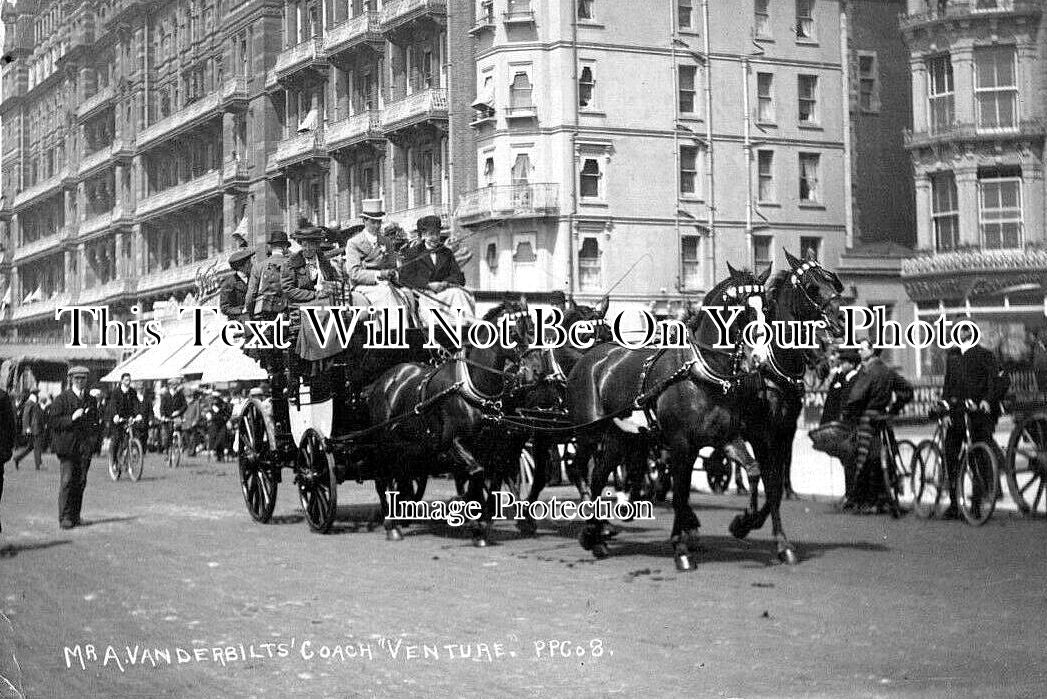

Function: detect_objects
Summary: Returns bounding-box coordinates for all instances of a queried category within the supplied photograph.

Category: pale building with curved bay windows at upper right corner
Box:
[900,0,1047,375]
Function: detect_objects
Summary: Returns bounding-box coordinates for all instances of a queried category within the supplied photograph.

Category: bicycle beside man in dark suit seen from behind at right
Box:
[912,401,1002,526]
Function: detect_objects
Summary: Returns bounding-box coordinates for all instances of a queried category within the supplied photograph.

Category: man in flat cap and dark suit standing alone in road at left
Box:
[50,366,101,529]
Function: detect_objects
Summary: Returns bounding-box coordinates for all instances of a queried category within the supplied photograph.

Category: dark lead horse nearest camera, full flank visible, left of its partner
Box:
[567,269,770,570]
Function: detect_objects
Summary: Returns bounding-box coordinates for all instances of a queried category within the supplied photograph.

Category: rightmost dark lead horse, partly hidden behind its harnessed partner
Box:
[731,251,843,563]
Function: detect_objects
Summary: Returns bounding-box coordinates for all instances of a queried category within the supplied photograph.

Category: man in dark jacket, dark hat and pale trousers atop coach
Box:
[400,216,476,324]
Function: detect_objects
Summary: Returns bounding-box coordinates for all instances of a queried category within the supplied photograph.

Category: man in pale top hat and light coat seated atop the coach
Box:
[344,199,414,316]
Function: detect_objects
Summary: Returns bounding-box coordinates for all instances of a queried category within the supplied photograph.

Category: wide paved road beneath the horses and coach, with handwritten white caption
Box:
[0,449,1047,697]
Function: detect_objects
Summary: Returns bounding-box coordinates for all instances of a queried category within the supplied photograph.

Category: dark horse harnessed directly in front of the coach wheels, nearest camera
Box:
[364,301,533,546]
